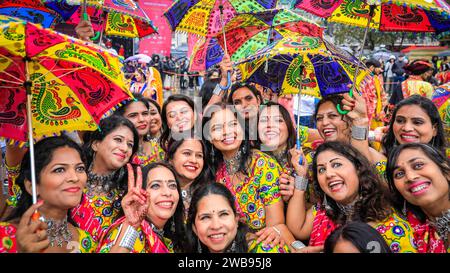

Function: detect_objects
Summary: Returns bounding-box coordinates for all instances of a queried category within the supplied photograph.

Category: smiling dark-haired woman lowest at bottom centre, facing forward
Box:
[186,183,287,253]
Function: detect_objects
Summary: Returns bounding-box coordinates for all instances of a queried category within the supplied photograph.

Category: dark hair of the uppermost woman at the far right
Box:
[381,95,446,153]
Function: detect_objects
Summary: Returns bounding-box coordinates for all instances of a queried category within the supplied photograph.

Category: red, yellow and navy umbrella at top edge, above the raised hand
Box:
[45,0,157,38]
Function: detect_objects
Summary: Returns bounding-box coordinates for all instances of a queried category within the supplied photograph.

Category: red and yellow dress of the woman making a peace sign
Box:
[97,217,173,253]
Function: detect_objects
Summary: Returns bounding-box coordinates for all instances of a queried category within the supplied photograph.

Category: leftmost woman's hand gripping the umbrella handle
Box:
[16,200,50,253]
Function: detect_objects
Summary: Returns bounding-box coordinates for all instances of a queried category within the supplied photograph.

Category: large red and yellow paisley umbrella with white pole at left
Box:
[0,16,132,203]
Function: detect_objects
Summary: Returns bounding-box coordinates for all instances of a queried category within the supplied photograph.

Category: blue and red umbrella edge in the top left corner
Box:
[0,0,59,28]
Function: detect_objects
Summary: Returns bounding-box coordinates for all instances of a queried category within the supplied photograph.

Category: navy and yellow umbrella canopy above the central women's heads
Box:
[239,36,367,98]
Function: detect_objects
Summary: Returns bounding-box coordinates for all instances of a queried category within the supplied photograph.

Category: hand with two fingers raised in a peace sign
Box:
[122,163,150,229]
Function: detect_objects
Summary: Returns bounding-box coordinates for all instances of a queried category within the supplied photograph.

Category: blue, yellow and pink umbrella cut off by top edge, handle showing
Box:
[164,0,277,86]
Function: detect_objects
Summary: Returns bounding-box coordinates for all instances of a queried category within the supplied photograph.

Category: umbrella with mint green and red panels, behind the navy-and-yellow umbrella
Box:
[216,9,323,62]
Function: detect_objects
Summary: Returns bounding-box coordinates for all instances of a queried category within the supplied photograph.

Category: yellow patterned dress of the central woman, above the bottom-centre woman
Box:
[216,150,281,230]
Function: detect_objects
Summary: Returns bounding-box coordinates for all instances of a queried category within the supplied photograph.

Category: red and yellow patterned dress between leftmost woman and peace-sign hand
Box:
[71,189,124,242]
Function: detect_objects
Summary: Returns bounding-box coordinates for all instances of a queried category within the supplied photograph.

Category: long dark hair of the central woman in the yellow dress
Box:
[202,102,252,174]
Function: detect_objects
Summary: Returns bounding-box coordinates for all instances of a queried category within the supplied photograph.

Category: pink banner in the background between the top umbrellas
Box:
[139,0,173,56]
